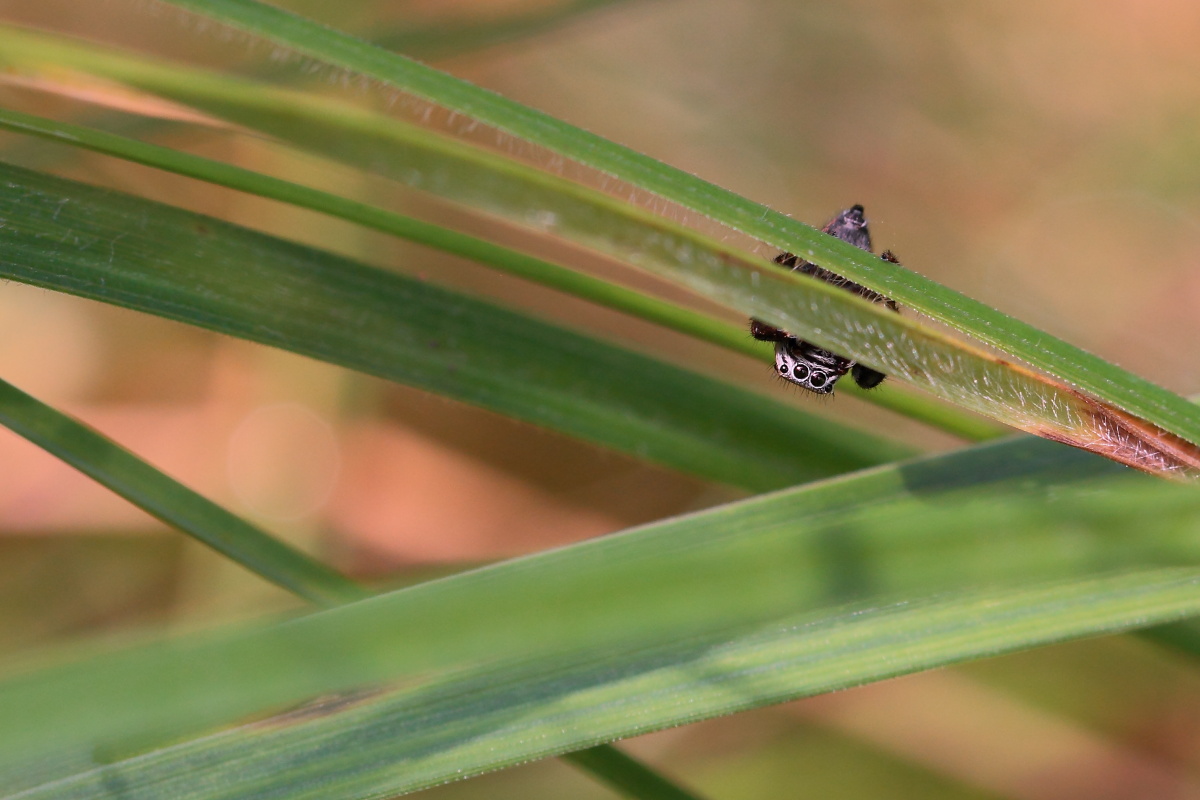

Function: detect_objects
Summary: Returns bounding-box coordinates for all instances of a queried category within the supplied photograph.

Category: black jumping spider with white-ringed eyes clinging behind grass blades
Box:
[750,205,900,395]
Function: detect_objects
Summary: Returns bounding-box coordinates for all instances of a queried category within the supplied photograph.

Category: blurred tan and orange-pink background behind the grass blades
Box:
[0,0,1200,800]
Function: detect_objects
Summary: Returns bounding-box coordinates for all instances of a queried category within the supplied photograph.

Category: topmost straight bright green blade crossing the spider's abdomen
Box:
[147,0,1200,445]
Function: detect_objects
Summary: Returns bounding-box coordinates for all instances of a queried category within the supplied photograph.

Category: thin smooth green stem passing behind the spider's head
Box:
[0,109,1003,440]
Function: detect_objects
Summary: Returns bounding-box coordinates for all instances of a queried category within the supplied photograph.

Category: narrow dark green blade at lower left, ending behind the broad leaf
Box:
[0,380,364,606]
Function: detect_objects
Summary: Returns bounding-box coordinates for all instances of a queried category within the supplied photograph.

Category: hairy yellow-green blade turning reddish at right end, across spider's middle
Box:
[0,30,1180,477]
